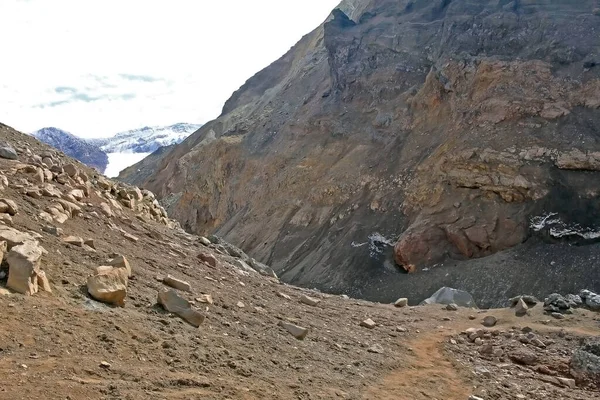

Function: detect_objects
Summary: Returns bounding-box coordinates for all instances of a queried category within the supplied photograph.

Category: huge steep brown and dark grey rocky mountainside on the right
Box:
[121,0,600,304]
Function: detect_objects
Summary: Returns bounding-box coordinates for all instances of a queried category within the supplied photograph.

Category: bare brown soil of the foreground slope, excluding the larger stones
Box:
[0,123,598,400]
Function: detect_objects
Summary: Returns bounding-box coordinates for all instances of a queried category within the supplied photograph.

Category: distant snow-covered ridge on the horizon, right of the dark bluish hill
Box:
[94,123,202,153]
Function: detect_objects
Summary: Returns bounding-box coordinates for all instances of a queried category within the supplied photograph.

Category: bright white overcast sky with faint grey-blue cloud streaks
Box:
[0,0,340,137]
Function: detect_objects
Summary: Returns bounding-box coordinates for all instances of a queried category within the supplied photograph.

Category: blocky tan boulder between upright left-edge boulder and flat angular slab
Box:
[87,267,127,307]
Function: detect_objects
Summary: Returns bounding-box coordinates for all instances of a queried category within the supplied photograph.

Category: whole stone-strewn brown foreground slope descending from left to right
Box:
[0,125,600,400]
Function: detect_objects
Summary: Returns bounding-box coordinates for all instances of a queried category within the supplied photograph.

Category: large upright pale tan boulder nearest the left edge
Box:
[6,241,43,295]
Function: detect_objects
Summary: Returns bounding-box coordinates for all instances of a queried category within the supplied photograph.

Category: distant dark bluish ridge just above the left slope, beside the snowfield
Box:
[32,128,108,172]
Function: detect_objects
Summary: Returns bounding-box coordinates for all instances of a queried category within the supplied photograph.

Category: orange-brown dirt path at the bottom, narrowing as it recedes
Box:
[365,332,472,400]
